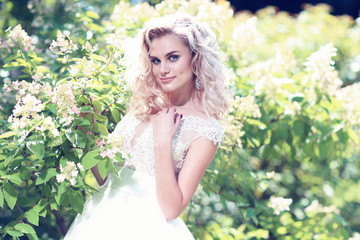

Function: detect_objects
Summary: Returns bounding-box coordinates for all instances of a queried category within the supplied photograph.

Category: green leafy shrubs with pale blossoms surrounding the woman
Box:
[0,0,360,239]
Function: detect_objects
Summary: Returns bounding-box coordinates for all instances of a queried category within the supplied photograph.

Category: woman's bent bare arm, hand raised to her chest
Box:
[154,110,217,220]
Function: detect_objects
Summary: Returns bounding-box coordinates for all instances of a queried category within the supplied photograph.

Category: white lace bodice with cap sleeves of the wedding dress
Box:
[113,111,222,175]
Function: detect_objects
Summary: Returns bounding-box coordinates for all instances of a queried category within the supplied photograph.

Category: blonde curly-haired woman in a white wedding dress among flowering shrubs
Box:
[65,15,228,240]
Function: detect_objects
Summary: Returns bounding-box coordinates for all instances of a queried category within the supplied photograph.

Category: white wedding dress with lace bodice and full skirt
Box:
[64,111,222,240]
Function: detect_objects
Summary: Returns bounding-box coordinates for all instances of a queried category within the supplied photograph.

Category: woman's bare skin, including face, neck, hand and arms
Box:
[92,34,217,221]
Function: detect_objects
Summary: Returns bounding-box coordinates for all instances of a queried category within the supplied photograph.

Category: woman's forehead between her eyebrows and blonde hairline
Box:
[149,34,190,55]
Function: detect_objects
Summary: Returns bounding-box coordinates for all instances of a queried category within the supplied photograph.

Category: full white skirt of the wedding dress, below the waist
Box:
[64,168,194,240]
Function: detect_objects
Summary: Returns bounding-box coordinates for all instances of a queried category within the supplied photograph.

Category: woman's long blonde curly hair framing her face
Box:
[126,14,229,120]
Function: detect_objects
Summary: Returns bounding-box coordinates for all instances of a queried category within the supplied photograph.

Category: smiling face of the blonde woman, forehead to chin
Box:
[149,34,194,97]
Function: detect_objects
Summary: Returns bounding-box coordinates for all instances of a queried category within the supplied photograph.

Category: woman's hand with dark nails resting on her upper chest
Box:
[153,107,182,146]
